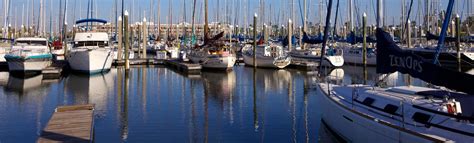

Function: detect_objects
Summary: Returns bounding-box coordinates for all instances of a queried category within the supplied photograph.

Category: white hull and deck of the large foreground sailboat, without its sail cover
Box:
[317,83,472,143]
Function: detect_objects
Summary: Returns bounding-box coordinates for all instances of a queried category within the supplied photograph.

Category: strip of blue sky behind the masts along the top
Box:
[0,0,470,31]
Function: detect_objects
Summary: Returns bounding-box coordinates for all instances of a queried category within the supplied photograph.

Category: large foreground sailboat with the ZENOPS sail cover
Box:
[318,0,474,142]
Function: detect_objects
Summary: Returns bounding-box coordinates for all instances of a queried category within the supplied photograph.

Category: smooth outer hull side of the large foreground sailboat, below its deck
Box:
[317,84,462,143]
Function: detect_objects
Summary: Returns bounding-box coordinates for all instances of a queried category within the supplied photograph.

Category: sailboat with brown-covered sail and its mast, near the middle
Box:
[187,0,237,70]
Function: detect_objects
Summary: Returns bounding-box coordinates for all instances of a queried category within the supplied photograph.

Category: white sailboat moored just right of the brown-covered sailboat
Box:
[242,43,291,69]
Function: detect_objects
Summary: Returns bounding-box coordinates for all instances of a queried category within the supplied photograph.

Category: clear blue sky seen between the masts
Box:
[0,0,474,32]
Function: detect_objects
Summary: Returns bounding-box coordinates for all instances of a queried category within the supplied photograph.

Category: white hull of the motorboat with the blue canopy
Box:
[68,48,114,73]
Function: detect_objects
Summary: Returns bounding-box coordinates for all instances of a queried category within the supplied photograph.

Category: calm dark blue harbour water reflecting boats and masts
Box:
[0,66,430,143]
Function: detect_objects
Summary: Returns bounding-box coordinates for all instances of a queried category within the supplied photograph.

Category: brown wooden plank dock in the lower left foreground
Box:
[37,105,94,143]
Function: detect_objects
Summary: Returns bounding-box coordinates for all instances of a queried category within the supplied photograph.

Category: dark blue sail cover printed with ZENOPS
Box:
[376,29,474,95]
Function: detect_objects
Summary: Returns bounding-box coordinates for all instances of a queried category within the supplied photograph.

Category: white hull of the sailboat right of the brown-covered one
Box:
[242,54,291,69]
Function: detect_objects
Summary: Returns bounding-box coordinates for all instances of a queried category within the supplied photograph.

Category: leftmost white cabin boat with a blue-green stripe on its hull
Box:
[5,37,53,73]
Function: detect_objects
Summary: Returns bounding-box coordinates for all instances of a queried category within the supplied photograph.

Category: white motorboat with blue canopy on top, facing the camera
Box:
[68,19,114,74]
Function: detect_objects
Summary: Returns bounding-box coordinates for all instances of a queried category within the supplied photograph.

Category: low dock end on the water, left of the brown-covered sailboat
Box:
[165,60,202,74]
